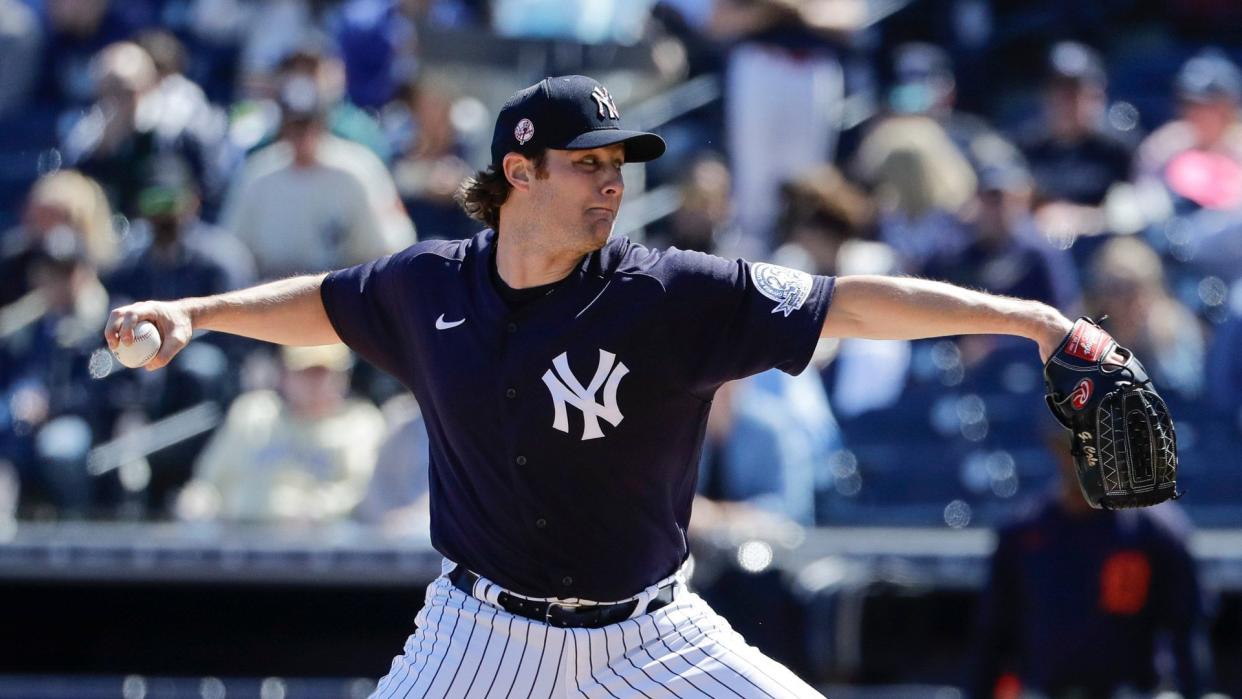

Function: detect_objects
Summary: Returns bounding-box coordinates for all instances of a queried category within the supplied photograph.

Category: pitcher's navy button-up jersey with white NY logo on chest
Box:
[323,231,833,600]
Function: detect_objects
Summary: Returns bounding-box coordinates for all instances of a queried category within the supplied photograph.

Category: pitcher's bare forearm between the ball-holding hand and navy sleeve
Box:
[180,273,340,345]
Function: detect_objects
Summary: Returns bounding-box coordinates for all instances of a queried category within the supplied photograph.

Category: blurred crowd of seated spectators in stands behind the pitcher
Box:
[0,0,1242,543]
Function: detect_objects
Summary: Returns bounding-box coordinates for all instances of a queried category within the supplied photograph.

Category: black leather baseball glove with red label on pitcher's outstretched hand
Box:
[1043,318,1181,509]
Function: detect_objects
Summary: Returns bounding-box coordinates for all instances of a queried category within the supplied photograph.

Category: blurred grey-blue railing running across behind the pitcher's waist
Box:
[9,521,1242,591]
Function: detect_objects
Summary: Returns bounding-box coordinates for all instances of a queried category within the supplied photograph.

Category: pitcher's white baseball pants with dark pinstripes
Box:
[371,564,822,699]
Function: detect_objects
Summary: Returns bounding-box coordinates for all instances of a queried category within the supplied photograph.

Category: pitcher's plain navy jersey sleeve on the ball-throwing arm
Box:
[319,253,412,380]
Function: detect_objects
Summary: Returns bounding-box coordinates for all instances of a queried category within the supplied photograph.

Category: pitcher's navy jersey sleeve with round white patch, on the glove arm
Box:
[661,250,836,391]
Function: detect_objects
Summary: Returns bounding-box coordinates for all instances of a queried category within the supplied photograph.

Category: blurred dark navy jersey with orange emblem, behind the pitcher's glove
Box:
[972,502,1203,697]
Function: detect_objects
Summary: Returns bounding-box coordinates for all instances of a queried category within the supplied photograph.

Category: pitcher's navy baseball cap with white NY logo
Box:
[492,76,664,169]
